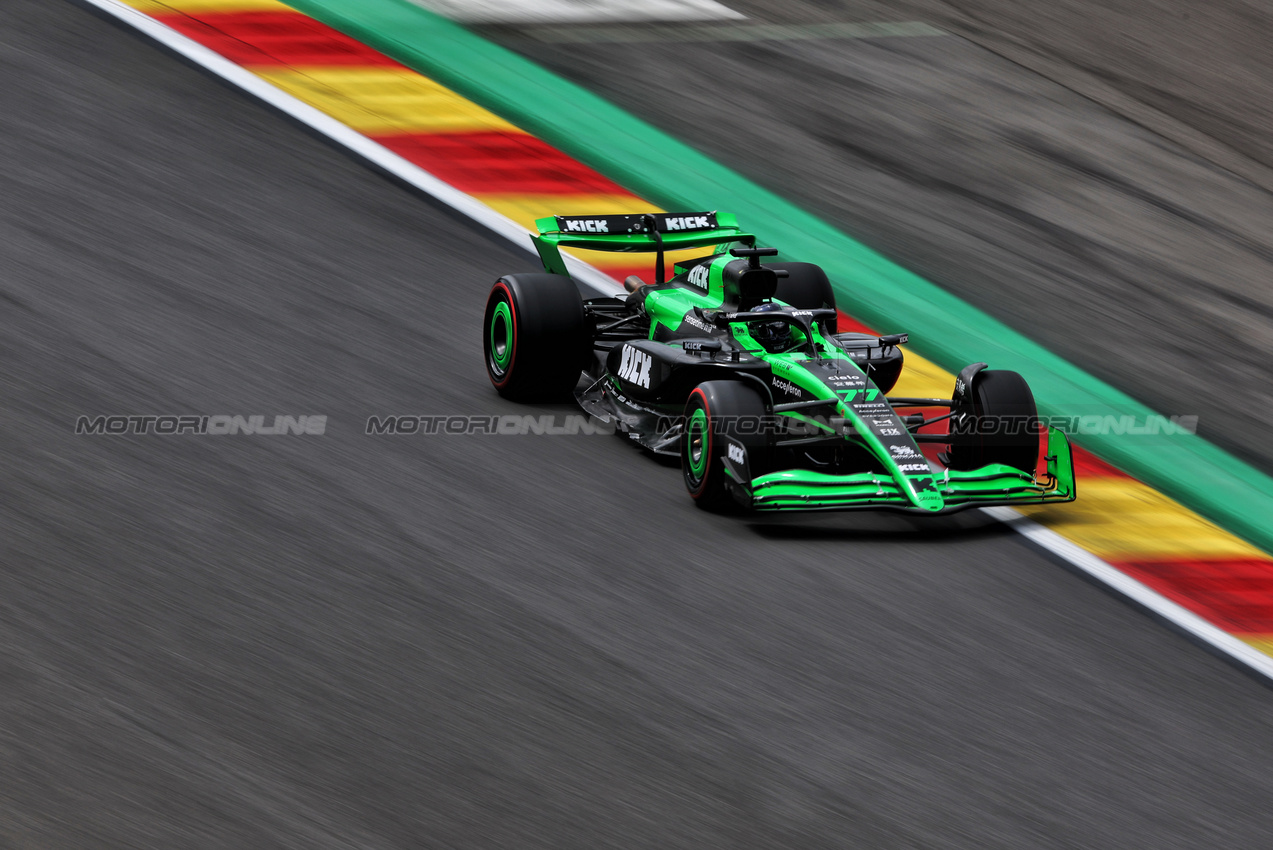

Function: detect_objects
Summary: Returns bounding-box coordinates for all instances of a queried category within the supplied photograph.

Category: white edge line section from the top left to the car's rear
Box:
[74,0,622,295]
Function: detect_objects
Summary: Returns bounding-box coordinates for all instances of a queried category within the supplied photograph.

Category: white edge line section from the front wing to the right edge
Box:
[981,508,1273,679]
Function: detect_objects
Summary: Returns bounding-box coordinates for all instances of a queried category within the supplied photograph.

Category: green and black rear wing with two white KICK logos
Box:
[531,213,756,282]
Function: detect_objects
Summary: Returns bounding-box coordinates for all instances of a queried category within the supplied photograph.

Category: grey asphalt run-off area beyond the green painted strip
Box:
[485,0,1273,472]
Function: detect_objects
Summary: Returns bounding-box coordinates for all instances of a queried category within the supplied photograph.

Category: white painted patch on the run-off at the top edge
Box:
[411,0,746,24]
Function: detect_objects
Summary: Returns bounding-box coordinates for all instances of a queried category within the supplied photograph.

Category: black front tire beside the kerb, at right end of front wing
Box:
[947,369,1039,475]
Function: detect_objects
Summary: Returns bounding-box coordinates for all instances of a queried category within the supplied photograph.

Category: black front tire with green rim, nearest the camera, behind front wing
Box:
[681,380,773,512]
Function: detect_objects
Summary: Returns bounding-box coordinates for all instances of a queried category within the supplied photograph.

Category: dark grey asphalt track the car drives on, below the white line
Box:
[7,0,1273,849]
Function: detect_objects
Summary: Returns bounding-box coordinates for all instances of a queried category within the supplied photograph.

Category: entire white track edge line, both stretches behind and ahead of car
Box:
[81,0,1273,679]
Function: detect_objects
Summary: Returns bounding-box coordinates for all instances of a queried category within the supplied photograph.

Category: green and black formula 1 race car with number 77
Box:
[482,213,1074,513]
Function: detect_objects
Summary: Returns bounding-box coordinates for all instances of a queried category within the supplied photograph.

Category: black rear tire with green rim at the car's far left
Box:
[482,275,591,401]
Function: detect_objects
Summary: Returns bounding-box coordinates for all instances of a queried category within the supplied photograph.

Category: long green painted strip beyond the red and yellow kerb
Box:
[288,0,1273,552]
